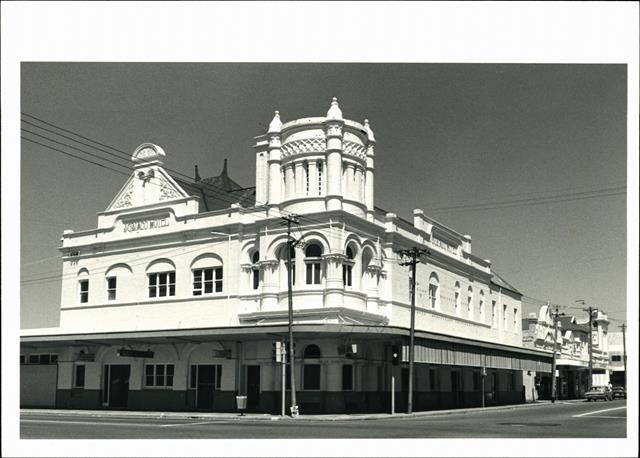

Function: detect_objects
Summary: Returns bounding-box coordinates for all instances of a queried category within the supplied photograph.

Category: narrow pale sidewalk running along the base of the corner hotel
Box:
[20,399,584,421]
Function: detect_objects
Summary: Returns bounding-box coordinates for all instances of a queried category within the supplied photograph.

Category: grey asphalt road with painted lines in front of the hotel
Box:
[20,400,627,439]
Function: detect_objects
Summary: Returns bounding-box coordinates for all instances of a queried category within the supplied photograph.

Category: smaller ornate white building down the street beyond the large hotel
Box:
[522,305,609,399]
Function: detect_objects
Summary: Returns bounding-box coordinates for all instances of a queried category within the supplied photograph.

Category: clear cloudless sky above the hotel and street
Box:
[20,62,627,329]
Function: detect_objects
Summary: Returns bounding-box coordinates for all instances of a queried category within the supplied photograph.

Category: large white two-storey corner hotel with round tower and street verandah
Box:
[21,99,550,414]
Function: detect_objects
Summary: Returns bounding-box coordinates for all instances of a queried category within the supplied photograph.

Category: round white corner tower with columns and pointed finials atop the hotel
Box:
[254,97,375,219]
